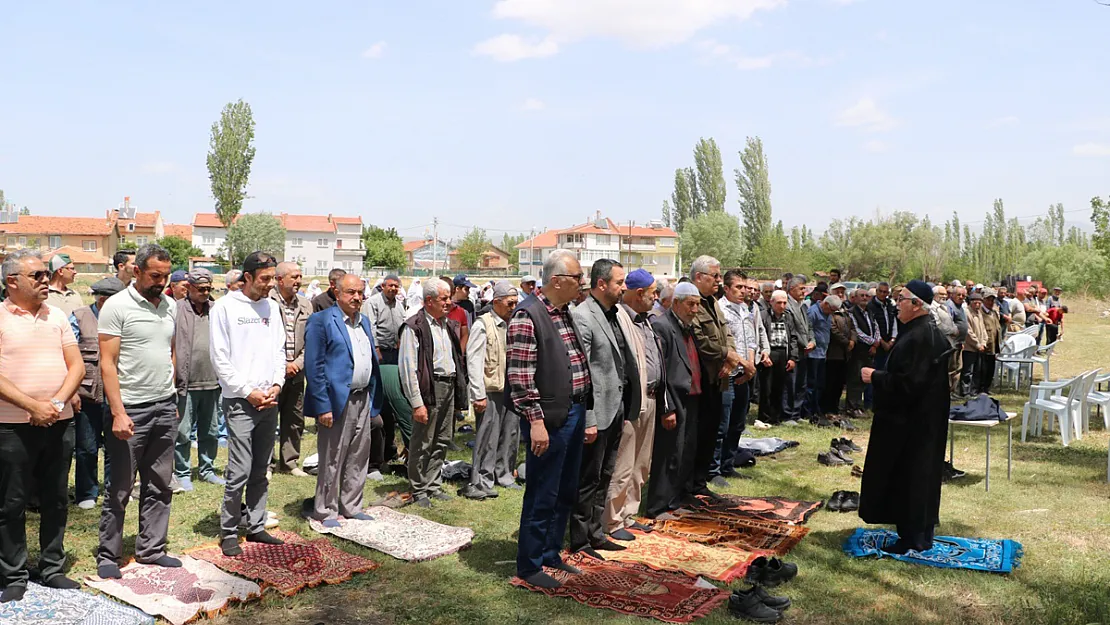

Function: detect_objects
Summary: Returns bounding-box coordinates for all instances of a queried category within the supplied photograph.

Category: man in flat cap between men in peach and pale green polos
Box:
[70,275,127,510]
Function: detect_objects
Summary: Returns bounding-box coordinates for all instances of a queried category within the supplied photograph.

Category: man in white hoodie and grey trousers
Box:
[210,252,285,556]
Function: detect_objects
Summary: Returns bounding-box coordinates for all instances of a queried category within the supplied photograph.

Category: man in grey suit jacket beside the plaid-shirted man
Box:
[569,259,642,560]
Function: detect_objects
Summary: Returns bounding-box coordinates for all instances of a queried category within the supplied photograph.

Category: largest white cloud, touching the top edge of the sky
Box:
[476,0,787,60]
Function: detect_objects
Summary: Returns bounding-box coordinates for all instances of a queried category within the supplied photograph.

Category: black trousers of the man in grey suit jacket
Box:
[568,415,624,552]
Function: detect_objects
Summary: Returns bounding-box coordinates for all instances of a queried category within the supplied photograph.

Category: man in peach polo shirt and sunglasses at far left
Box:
[0,250,84,603]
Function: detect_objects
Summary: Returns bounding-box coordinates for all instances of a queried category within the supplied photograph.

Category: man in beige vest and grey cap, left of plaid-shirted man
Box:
[458,280,521,500]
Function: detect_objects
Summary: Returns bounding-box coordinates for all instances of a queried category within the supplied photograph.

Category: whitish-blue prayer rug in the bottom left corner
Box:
[0,584,154,625]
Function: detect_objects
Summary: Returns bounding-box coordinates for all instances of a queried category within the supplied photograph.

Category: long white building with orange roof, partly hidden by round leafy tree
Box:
[193,213,366,275]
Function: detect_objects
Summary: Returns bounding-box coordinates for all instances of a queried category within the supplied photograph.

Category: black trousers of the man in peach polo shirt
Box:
[0,419,77,587]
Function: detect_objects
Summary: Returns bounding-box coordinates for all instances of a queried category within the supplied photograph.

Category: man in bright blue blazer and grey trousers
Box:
[304,274,382,527]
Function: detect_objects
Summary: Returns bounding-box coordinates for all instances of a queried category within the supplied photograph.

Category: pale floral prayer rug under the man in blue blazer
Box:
[309,506,474,562]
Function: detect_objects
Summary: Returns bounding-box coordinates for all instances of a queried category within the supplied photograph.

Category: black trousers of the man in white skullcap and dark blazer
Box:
[644,395,700,518]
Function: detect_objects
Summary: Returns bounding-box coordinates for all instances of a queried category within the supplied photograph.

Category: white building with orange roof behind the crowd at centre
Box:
[516,214,678,279]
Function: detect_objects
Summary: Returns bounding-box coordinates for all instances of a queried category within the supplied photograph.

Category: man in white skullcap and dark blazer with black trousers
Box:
[645,282,701,518]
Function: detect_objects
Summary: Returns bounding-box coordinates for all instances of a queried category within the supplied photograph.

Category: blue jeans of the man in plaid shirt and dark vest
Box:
[516,404,586,578]
